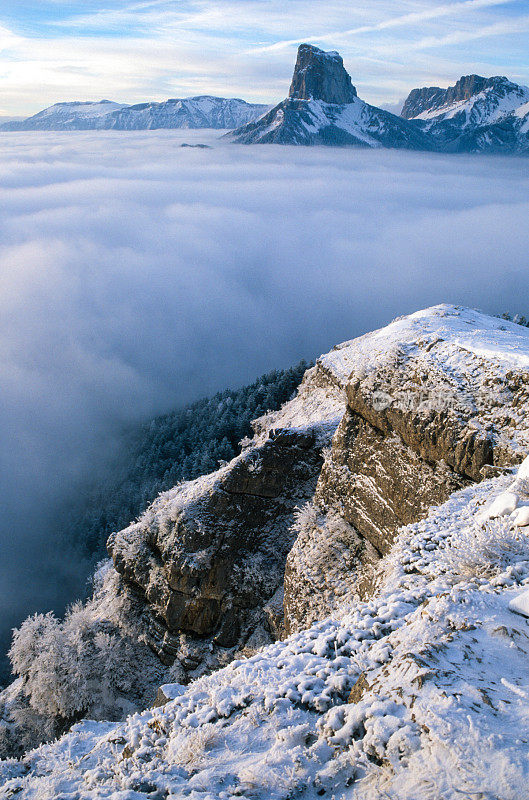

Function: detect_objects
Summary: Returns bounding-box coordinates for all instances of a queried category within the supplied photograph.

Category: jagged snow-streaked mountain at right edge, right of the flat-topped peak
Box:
[402,75,529,153]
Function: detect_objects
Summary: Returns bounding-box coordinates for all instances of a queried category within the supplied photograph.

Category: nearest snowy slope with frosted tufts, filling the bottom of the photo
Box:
[0,466,529,800]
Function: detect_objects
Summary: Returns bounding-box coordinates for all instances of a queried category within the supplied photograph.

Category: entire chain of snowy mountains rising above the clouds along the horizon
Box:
[4,44,529,154]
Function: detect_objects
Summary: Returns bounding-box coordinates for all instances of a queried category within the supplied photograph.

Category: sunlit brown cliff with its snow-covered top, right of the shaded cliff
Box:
[285,307,529,633]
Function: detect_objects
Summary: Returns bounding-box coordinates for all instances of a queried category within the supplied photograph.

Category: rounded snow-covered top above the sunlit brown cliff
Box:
[318,304,529,460]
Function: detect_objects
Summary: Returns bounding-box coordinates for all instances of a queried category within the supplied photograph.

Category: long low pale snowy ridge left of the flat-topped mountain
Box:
[0,95,269,131]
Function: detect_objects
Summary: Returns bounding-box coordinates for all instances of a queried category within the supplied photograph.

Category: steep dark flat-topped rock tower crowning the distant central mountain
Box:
[289,44,356,105]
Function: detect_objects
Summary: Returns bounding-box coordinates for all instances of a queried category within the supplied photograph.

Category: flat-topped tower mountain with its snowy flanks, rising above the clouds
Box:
[230,44,430,150]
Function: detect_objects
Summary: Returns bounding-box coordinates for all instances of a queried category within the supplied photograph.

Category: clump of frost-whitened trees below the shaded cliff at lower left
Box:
[9,568,161,721]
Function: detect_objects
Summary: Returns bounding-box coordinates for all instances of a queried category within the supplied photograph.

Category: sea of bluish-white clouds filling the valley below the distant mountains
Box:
[0,131,529,676]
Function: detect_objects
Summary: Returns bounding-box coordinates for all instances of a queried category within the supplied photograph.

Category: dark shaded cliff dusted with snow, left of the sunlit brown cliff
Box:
[108,429,321,661]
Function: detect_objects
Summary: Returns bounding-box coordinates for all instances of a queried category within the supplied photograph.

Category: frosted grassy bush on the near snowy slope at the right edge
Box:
[440,517,529,579]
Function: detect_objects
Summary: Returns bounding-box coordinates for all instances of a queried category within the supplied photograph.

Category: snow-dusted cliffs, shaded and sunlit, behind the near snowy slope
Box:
[4,305,529,752]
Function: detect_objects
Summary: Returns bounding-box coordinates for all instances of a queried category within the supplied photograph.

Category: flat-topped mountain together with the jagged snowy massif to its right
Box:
[230,44,529,153]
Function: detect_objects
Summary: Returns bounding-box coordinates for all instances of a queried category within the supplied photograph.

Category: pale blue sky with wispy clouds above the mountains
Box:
[0,0,529,115]
